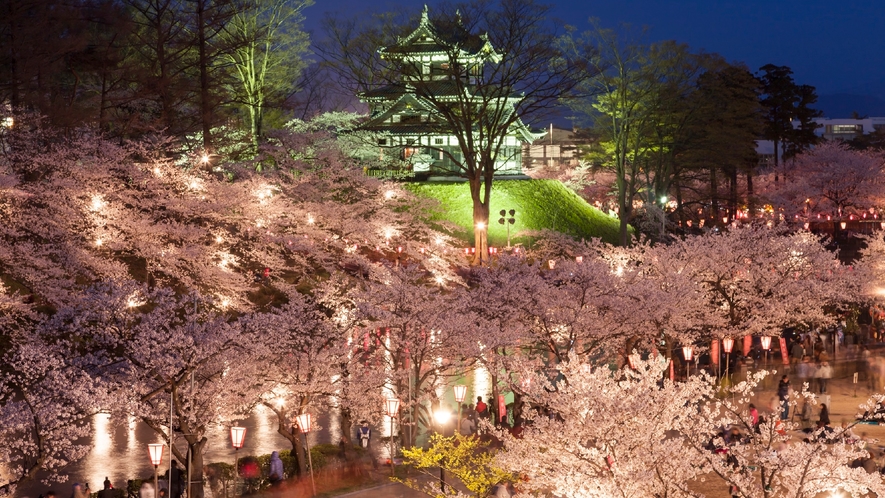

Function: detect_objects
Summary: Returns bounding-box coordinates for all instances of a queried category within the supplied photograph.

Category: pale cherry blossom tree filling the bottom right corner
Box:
[682,371,885,498]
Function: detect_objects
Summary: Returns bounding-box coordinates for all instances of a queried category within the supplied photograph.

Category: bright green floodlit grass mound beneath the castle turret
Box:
[405,180,618,246]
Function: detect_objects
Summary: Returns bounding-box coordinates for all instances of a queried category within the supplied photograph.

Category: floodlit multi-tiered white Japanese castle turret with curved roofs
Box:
[360,6,544,176]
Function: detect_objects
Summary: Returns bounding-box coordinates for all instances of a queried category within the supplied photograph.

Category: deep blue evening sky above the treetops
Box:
[305,0,885,98]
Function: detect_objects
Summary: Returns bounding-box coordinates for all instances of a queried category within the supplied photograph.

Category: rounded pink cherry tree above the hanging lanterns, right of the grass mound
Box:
[667,226,864,337]
